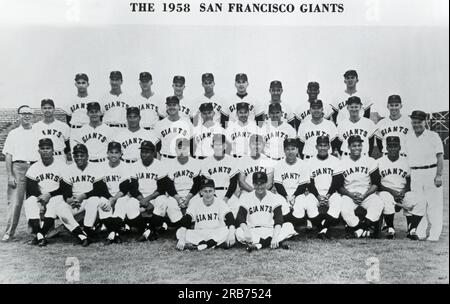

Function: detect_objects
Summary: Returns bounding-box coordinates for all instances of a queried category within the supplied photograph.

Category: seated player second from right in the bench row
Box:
[339,135,384,238]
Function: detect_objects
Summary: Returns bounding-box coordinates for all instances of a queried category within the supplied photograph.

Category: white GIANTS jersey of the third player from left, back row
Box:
[129,94,166,128]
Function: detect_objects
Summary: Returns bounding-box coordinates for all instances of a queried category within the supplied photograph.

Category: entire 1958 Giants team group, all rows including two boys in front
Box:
[3,70,443,251]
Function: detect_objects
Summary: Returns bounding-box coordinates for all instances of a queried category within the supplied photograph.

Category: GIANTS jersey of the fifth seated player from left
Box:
[164,157,202,192]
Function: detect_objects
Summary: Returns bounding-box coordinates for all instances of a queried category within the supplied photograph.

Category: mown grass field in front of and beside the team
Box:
[0,161,449,284]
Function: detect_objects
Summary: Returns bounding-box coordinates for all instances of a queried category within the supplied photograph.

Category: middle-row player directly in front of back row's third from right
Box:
[261,103,296,161]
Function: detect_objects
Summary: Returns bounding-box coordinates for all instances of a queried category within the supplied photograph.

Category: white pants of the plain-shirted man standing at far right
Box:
[411,168,444,240]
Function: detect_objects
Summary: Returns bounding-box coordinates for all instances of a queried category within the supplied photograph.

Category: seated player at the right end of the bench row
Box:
[378,136,425,240]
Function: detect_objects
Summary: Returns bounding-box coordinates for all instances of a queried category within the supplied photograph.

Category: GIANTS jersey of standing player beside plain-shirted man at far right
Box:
[375,116,412,152]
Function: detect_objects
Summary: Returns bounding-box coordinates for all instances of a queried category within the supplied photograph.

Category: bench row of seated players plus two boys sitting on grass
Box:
[25,134,424,251]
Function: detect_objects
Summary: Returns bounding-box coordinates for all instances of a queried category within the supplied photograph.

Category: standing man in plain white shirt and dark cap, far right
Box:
[405,111,444,242]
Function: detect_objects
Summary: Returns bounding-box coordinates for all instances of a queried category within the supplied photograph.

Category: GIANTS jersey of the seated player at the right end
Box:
[378,155,410,191]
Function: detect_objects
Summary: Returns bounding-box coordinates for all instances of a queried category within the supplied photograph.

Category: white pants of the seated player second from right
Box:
[341,194,384,227]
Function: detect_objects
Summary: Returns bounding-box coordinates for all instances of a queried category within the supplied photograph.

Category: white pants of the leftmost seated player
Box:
[24,195,78,231]
